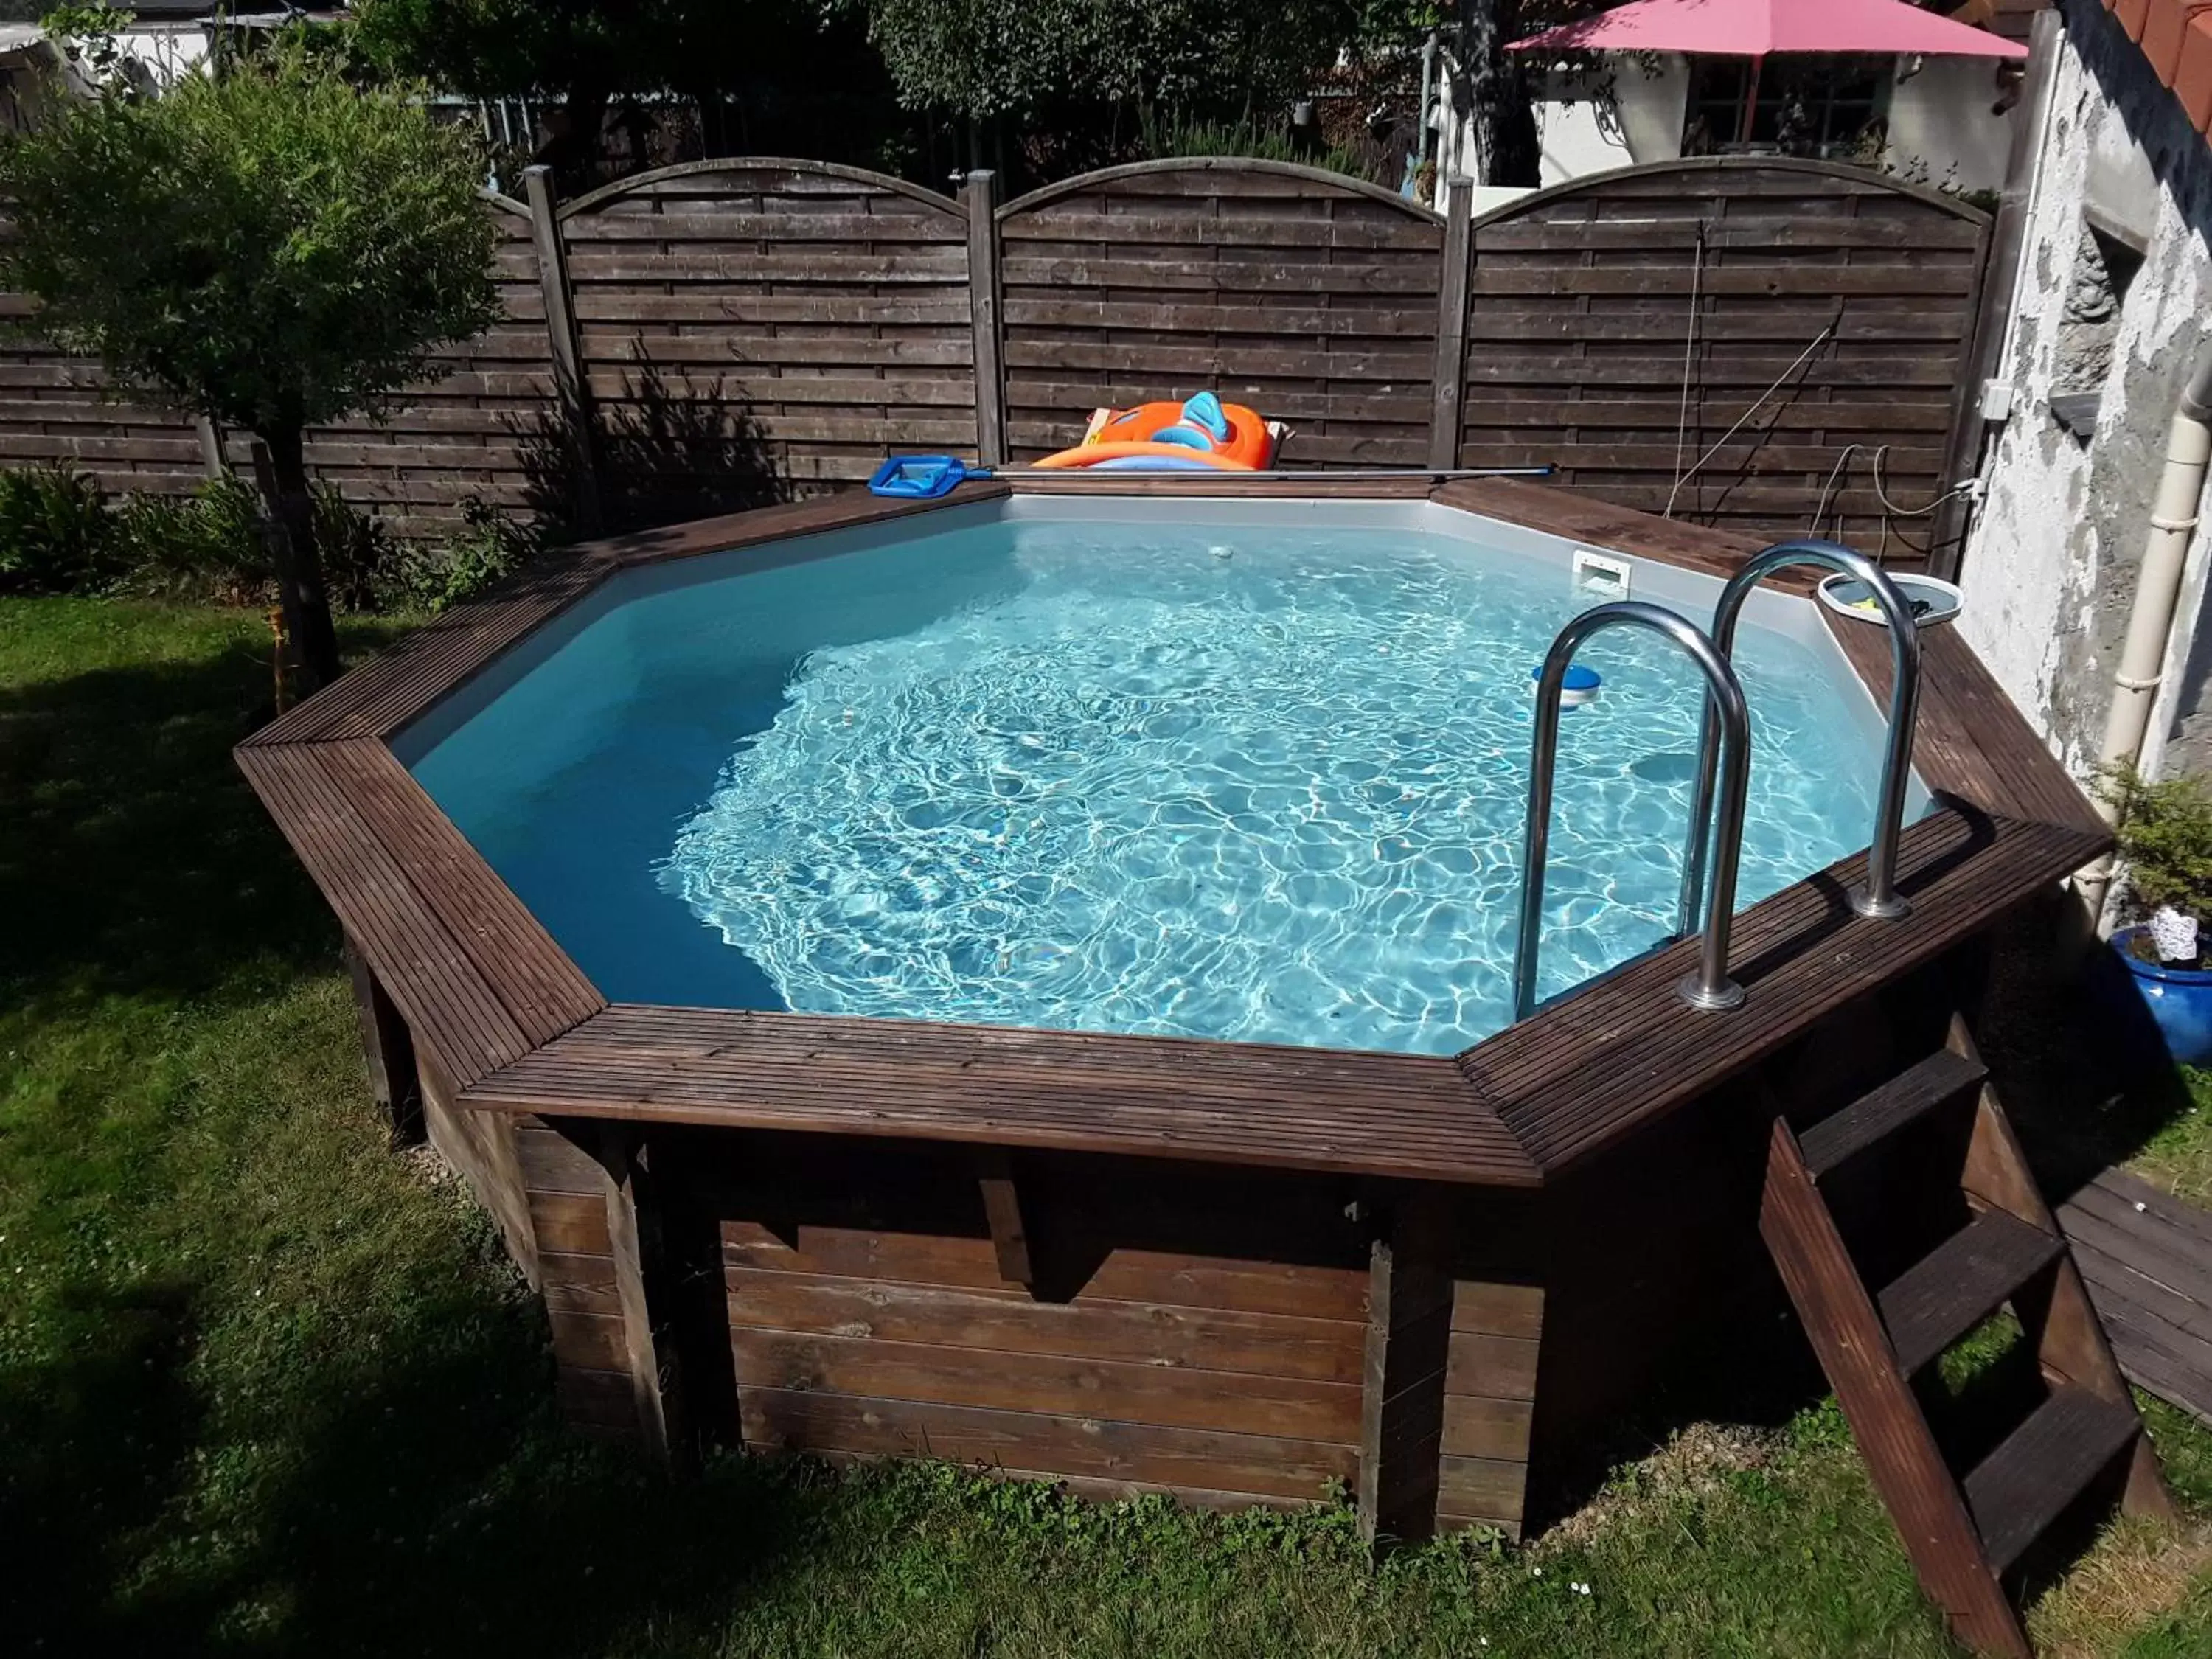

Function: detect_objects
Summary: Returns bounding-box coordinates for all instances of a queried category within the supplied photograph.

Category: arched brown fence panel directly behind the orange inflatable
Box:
[1000,161,1444,467]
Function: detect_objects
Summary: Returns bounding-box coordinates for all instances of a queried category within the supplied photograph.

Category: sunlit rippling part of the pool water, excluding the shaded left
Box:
[659,529,1871,1053]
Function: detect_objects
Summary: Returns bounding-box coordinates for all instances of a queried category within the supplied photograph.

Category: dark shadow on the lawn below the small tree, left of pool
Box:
[0,602,403,1002]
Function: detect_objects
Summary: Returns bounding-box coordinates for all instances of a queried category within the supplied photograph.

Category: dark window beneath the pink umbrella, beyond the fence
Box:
[1681,55,1889,161]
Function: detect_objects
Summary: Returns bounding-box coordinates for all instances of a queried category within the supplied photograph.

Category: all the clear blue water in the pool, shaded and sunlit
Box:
[414,511,1878,1053]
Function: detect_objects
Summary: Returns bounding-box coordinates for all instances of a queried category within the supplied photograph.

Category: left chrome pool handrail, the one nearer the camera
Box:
[1513,599,1752,1020]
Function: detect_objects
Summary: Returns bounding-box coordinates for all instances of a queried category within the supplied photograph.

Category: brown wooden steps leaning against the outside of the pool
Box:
[1761,1015,2172,1659]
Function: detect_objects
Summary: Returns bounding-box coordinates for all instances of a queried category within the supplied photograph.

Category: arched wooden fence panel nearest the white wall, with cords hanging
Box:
[1460,161,1989,566]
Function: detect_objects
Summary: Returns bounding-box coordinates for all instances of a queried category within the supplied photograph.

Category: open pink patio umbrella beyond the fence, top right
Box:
[1506,0,2028,139]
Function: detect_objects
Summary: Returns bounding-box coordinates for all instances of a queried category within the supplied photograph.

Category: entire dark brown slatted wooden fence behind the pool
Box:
[0,157,1991,564]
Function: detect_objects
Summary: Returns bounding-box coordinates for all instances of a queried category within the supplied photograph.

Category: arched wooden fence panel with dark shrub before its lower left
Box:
[562,161,975,487]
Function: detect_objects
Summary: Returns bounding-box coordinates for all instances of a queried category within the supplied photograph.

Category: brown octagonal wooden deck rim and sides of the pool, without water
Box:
[237,476,2108,1537]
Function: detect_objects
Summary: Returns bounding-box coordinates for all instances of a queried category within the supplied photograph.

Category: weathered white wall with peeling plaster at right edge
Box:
[1958,0,2212,774]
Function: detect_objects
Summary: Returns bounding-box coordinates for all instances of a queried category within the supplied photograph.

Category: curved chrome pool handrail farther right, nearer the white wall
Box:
[1677,540,1920,933]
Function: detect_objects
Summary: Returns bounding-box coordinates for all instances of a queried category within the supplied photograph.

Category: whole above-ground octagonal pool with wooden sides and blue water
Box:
[239,478,2110,1537]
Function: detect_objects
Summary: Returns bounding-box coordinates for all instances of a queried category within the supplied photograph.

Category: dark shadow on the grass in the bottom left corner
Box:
[0,1256,814,1659]
